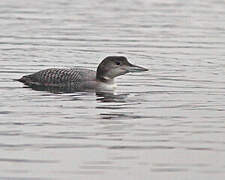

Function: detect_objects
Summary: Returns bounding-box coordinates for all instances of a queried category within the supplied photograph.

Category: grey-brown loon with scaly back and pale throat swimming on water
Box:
[18,56,148,91]
